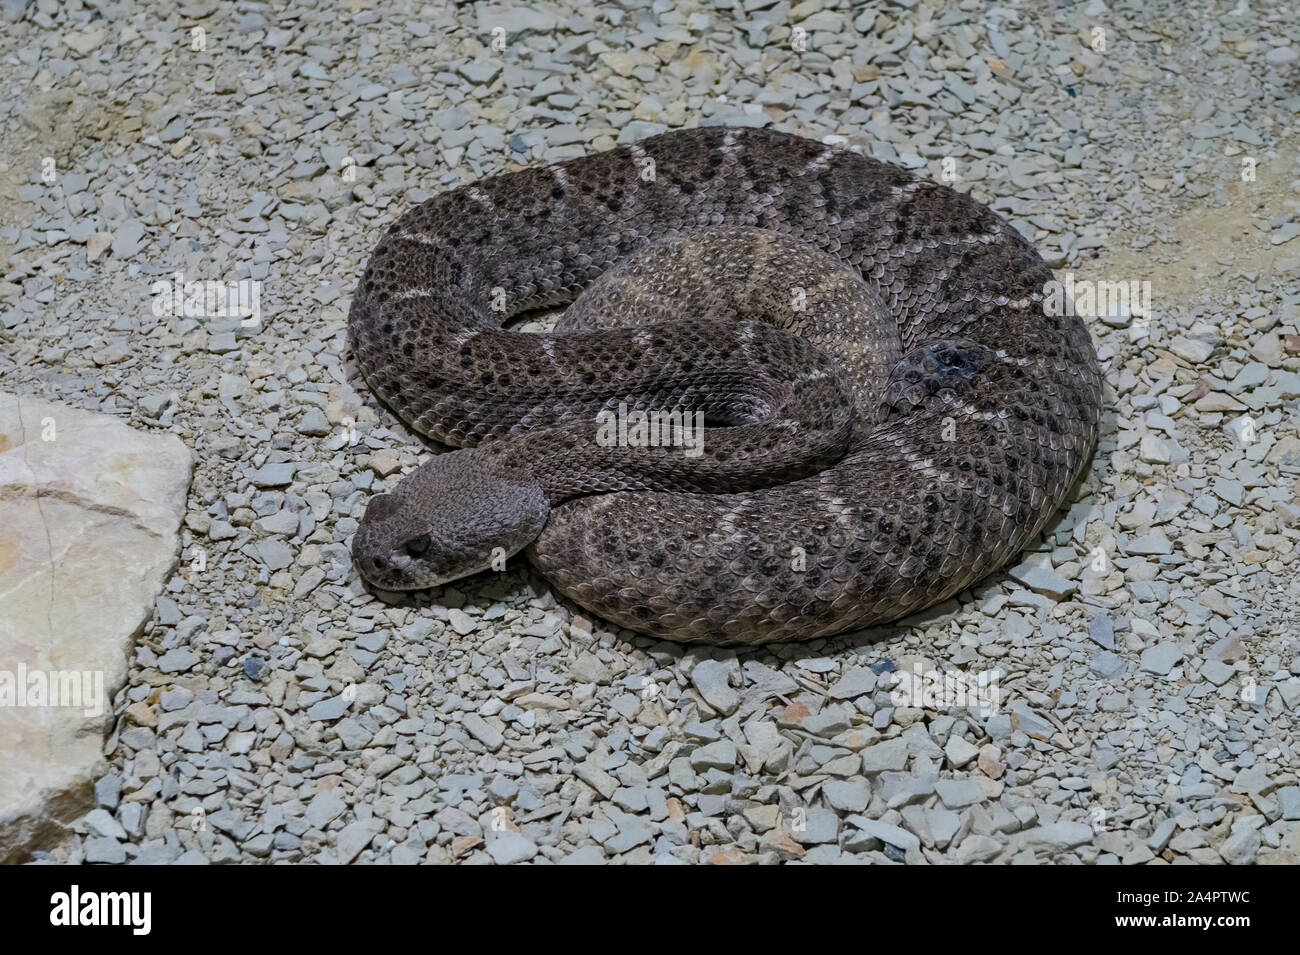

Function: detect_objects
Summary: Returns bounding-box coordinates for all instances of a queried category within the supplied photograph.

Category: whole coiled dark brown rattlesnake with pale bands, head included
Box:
[348,127,1101,644]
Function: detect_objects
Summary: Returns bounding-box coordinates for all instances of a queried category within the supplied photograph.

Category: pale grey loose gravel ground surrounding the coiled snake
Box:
[0,0,1300,864]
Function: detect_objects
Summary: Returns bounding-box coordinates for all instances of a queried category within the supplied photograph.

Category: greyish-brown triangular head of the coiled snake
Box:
[352,450,550,590]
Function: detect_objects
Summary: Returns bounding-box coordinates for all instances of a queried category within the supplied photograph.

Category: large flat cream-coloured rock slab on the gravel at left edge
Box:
[0,391,190,863]
